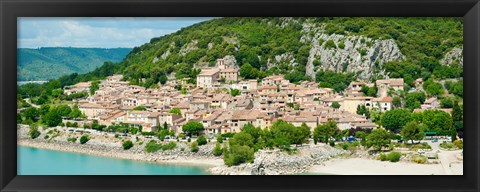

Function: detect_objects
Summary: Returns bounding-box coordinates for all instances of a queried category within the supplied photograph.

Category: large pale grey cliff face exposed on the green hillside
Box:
[306,33,404,79]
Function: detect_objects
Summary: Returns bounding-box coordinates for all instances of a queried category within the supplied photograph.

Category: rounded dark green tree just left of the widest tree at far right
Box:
[381,109,412,131]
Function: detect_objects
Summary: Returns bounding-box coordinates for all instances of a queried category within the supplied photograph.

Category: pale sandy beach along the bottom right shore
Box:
[309,158,454,175]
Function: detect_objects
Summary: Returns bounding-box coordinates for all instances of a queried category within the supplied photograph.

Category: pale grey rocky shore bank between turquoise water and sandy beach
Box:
[209,145,347,175]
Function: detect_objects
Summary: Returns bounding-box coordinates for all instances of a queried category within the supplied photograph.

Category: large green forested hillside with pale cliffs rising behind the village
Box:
[53,17,463,87]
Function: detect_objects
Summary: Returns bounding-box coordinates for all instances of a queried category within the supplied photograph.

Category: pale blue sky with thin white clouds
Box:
[17,17,212,48]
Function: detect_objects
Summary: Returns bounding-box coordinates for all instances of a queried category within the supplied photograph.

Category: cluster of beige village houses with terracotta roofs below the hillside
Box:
[64,59,438,136]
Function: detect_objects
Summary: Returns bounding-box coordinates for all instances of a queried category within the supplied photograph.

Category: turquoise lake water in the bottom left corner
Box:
[17,146,209,175]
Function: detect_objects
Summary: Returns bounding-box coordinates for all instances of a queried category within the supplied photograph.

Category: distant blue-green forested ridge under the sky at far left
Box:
[17,47,132,81]
